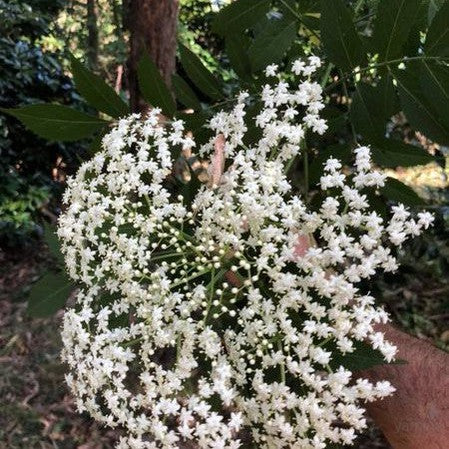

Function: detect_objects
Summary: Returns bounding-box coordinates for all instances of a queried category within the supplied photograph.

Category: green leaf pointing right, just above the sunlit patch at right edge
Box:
[372,139,435,168]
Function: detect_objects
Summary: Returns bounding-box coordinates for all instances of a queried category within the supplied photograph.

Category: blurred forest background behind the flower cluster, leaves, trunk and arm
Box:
[0,0,449,449]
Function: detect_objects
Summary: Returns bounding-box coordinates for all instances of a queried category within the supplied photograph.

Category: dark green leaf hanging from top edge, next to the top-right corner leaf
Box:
[373,0,421,62]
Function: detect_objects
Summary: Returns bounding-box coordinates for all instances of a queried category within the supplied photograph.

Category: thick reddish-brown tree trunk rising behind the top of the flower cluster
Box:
[126,0,179,112]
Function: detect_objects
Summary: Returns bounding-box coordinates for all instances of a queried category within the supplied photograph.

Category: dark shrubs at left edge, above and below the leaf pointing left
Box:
[0,0,88,247]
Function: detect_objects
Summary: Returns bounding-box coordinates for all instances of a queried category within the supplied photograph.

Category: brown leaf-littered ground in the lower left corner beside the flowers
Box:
[0,247,115,449]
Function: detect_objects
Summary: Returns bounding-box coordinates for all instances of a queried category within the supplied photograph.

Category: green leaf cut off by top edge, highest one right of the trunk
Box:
[212,0,270,35]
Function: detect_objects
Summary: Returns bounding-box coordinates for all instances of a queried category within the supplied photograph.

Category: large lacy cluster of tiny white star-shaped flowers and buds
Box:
[58,58,432,449]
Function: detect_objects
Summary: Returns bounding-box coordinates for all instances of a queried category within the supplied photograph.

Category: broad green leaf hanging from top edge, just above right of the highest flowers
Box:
[320,0,367,71]
